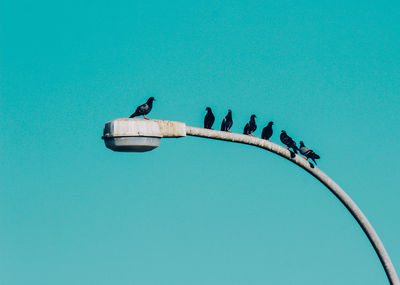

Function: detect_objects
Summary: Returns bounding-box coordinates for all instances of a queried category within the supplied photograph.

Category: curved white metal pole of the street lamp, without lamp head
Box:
[186,126,400,285]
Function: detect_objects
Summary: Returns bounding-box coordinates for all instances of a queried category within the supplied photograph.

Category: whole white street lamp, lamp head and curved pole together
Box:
[102,119,400,285]
